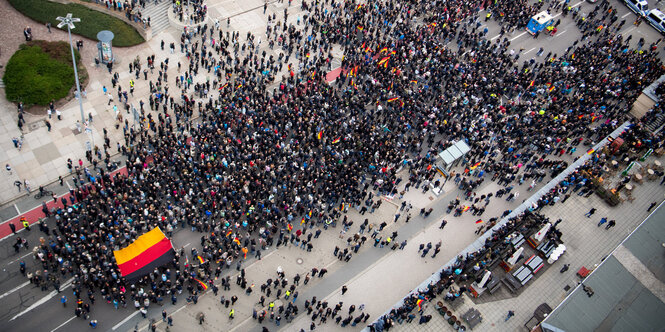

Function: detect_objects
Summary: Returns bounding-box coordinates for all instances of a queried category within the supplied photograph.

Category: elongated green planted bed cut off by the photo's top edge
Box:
[9,0,145,47]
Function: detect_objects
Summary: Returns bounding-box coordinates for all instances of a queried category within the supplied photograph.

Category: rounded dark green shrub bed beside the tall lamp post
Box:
[2,40,87,106]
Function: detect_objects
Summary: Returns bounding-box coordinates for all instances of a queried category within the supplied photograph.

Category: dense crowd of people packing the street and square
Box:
[11,0,663,330]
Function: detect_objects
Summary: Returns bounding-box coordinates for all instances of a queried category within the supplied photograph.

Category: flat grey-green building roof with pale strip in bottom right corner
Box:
[541,204,665,332]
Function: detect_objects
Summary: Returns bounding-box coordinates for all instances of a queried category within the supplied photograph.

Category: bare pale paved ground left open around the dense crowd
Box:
[0,0,665,332]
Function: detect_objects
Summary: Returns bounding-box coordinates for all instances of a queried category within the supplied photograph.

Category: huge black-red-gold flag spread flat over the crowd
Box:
[113,227,175,282]
